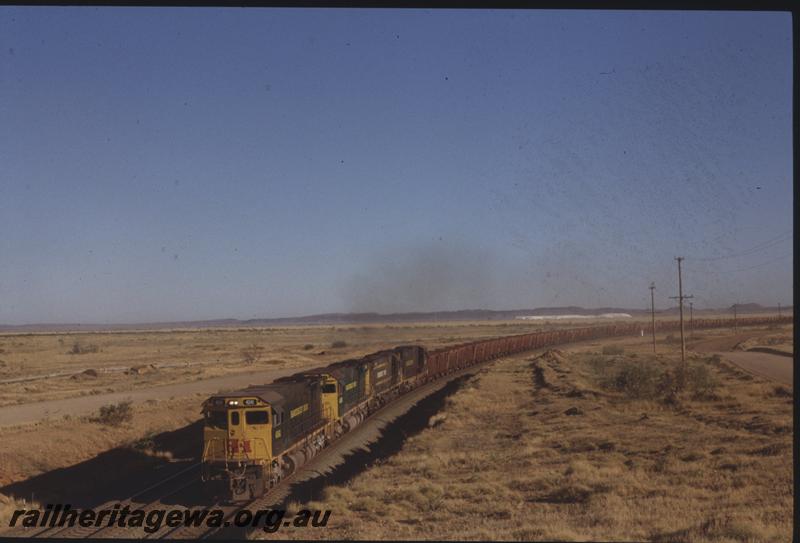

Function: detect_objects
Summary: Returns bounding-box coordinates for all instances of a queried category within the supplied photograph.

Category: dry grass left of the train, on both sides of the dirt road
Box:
[0,322,588,492]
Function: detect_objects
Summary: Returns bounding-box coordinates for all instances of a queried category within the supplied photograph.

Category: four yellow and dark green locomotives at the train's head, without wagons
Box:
[202,346,427,501]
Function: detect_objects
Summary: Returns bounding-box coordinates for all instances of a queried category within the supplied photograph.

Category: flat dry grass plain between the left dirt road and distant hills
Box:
[0,321,572,406]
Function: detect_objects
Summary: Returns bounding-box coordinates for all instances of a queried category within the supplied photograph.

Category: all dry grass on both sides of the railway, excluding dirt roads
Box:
[0,322,792,541]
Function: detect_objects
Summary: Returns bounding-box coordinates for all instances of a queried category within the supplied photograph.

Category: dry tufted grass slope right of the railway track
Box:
[270,332,793,542]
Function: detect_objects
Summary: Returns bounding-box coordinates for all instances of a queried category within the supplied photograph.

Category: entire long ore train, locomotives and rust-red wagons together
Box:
[202,317,792,502]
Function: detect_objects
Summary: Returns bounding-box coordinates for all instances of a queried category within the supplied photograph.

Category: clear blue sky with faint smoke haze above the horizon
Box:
[0,7,792,324]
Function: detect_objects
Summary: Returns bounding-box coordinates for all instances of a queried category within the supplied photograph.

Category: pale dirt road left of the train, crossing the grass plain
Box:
[0,368,298,427]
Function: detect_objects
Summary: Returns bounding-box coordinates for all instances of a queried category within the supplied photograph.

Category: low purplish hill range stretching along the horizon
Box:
[0,303,792,333]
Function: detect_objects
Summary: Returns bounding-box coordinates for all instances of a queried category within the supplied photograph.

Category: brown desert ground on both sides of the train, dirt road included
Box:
[0,321,793,541]
